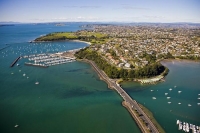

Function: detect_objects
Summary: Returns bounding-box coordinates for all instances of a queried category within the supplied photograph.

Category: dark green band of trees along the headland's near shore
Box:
[75,48,165,79]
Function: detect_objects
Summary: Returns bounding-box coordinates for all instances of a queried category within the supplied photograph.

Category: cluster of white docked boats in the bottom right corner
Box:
[176,120,200,133]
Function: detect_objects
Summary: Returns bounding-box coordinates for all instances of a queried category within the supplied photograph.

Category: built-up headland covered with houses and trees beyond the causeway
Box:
[34,24,200,83]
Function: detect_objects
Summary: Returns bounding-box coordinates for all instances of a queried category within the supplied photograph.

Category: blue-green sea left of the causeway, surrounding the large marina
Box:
[0,23,140,133]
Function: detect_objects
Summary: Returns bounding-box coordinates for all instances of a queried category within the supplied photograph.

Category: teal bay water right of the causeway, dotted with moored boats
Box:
[122,61,200,133]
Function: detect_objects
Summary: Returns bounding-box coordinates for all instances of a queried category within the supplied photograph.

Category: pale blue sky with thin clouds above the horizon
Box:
[0,0,200,23]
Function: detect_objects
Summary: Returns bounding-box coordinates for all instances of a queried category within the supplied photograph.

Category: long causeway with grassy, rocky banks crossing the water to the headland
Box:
[83,59,159,133]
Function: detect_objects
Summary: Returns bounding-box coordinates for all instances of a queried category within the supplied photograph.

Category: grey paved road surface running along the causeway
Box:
[87,60,159,133]
